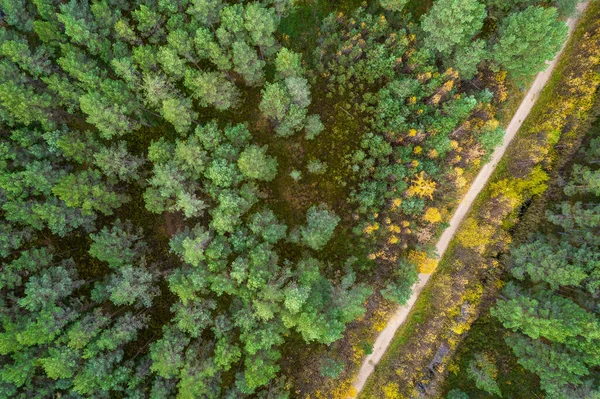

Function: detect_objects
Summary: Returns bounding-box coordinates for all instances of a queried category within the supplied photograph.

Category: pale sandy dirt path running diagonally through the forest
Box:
[353,2,589,396]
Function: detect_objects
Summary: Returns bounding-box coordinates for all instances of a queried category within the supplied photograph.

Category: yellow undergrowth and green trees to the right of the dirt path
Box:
[359,2,600,399]
